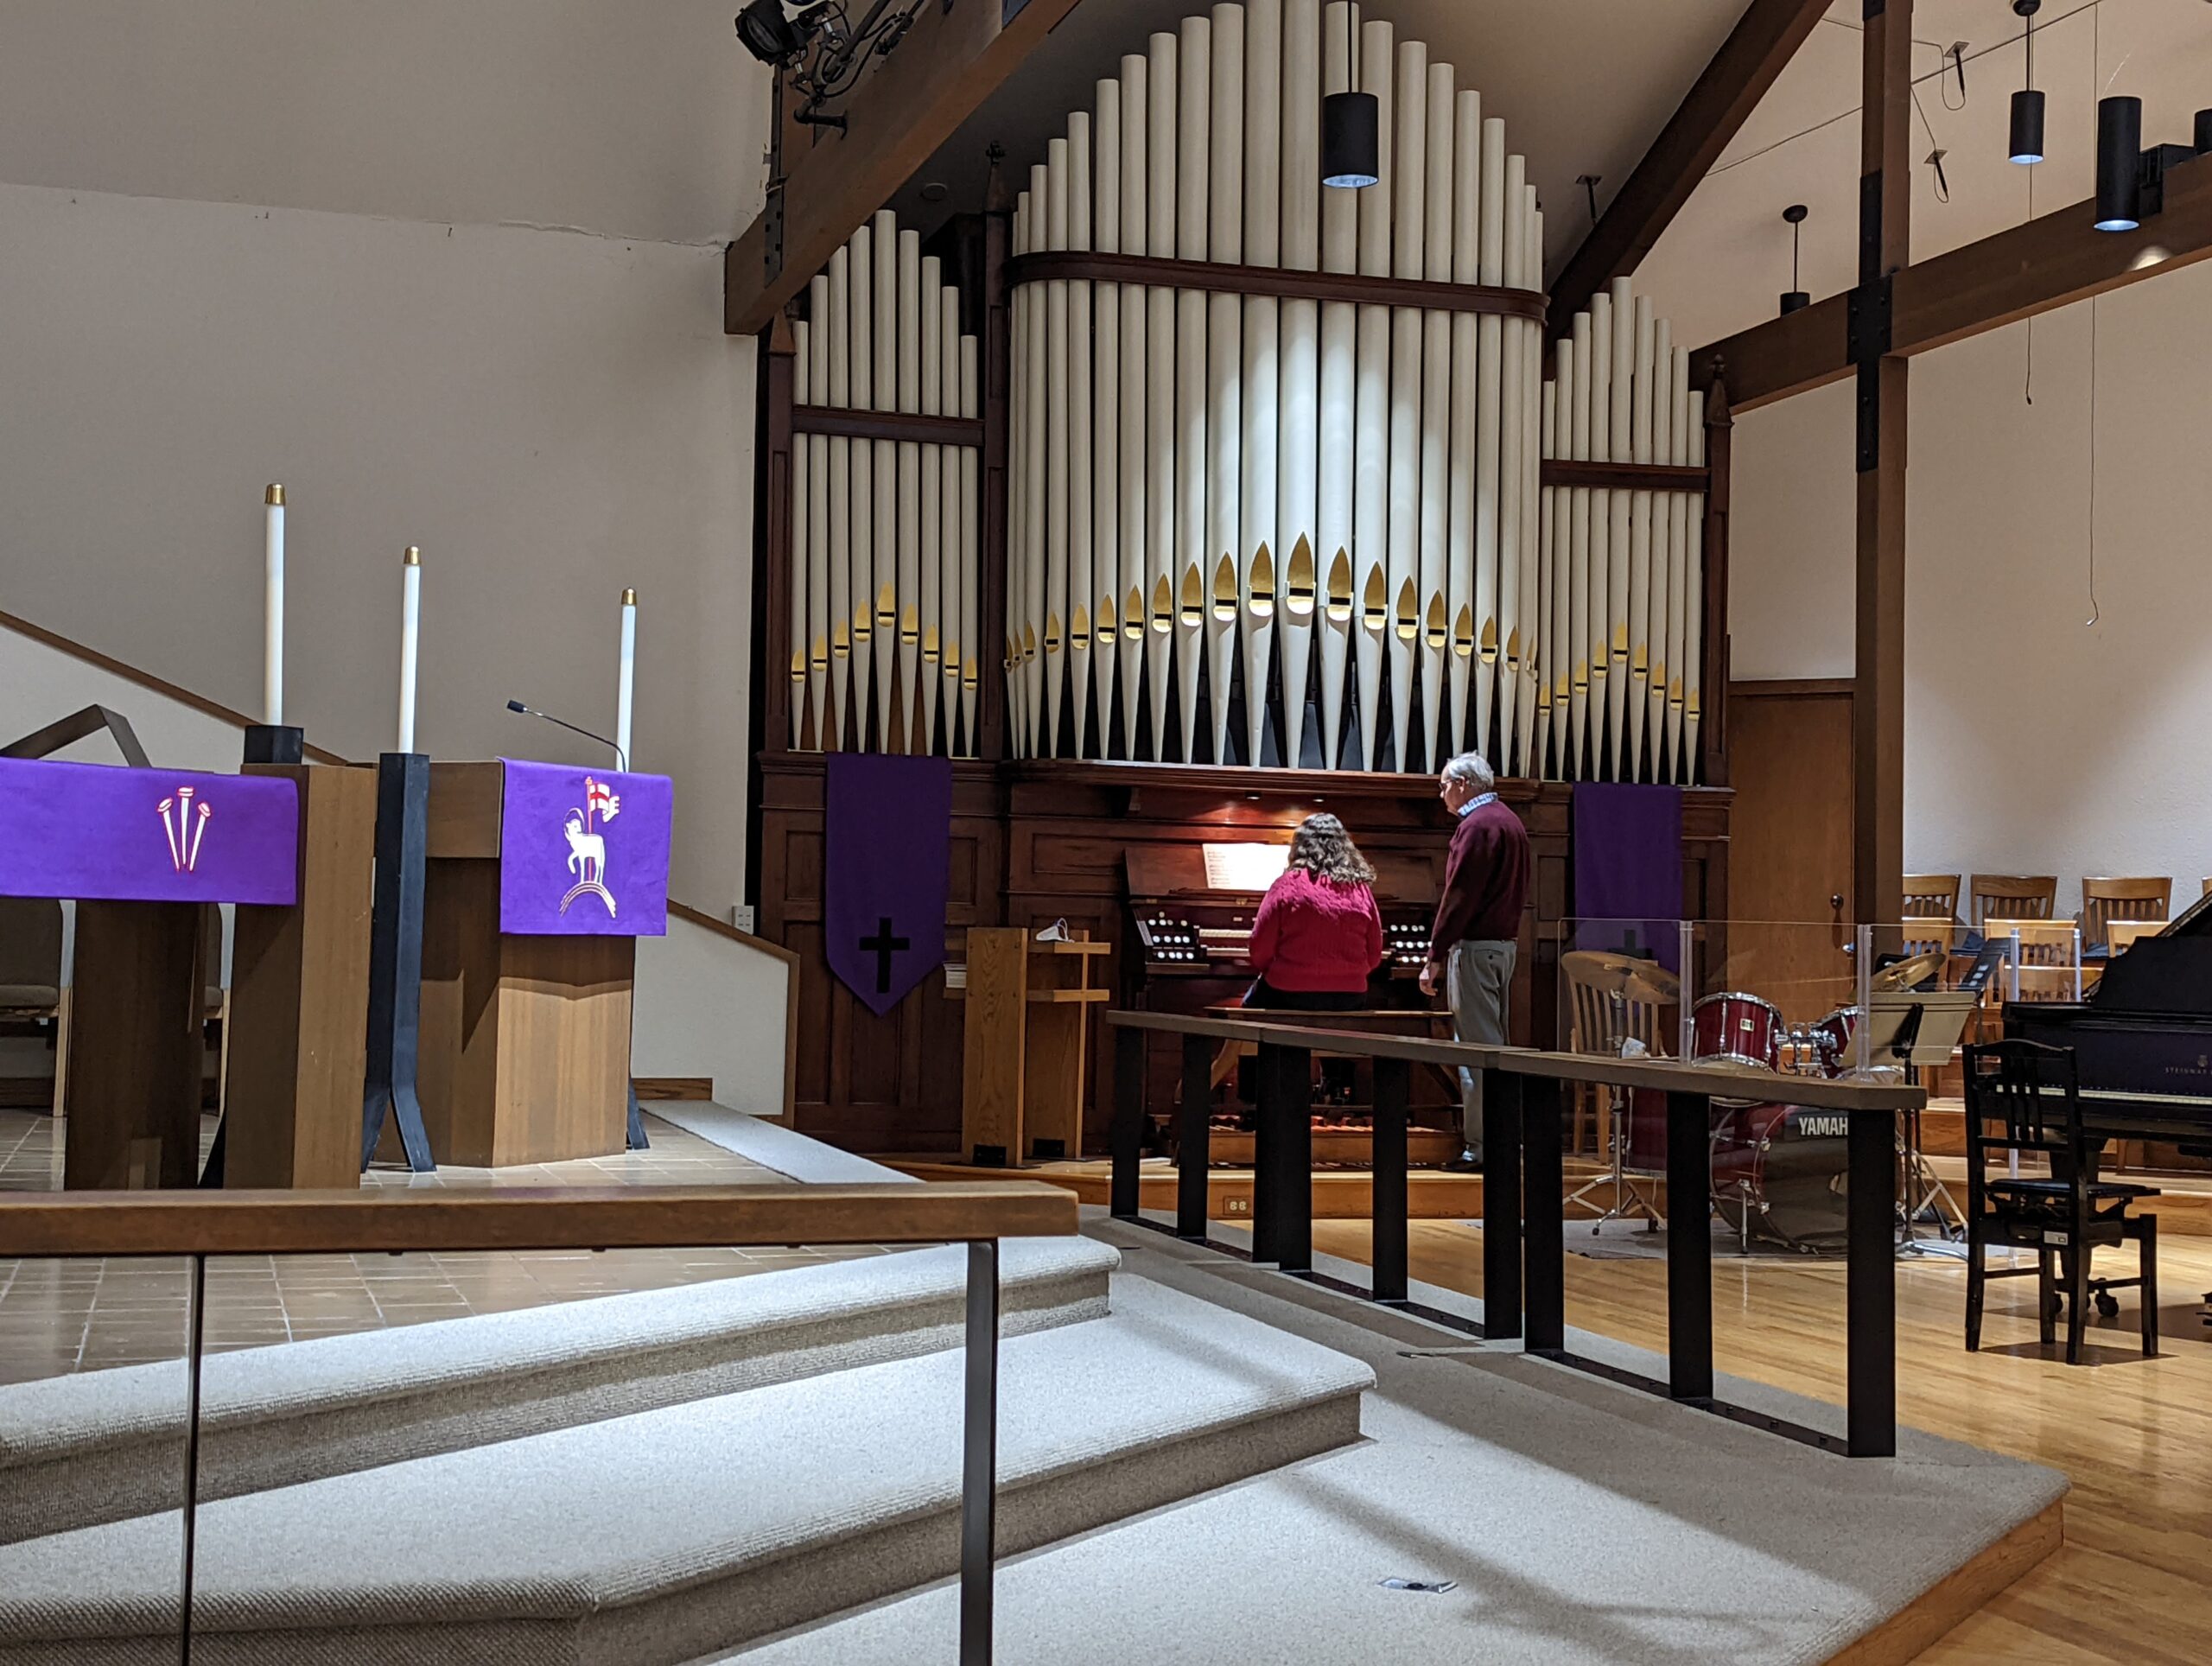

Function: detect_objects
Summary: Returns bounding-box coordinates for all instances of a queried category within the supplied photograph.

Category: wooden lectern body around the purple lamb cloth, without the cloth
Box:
[416,761,637,1168]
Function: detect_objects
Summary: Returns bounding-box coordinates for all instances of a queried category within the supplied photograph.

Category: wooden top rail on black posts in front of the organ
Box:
[1106,1011,1927,1113]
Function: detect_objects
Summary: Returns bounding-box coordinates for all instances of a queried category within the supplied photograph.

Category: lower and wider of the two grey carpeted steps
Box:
[0,1279,1374,1666]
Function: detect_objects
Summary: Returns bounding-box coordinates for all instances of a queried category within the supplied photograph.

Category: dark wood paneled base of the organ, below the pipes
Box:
[761,753,1730,1155]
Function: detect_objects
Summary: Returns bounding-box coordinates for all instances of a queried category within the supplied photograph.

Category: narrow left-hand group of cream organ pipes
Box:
[787,210,982,757]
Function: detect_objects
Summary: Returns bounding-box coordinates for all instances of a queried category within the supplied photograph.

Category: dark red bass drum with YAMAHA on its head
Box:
[1712,1104,1849,1255]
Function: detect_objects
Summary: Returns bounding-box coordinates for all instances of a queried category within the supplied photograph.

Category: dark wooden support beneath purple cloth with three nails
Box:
[62,903,204,1191]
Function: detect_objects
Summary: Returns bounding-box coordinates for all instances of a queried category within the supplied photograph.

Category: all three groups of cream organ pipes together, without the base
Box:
[779,0,1726,783]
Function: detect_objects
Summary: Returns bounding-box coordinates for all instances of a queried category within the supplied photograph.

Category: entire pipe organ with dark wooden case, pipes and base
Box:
[747,0,1730,1155]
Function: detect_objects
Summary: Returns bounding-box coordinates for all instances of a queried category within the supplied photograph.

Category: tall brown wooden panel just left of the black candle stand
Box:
[224,763,376,1188]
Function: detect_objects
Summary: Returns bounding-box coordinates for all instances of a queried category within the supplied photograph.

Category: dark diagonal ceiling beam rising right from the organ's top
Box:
[1551,0,1827,339]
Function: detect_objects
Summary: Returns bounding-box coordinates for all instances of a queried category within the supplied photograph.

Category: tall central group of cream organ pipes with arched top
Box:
[1002,0,1541,770]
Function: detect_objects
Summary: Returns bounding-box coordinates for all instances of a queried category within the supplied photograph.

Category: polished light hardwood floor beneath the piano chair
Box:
[1314,1221,2212,1666]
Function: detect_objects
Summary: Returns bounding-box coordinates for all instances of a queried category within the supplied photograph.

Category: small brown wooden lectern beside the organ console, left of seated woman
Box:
[960,925,1109,1168]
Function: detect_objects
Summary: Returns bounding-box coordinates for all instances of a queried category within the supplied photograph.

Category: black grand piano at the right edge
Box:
[2004,896,2212,1157]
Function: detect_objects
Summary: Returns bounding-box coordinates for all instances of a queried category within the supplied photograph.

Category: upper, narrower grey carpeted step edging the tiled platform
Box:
[0,1237,1122,1544]
